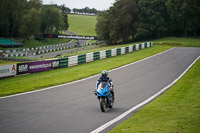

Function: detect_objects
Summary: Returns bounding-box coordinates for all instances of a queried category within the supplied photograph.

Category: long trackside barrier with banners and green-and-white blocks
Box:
[0,42,153,78]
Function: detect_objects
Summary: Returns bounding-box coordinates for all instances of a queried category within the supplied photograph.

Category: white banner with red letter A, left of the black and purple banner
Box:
[0,64,17,78]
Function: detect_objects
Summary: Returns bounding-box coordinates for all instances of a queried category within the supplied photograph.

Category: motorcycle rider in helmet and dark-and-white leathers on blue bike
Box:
[94,70,114,100]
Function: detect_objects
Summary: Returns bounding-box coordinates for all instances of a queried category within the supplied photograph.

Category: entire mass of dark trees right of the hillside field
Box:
[96,0,200,44]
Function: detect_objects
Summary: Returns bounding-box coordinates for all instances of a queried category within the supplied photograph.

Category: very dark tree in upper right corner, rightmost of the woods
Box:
[166,0,200,36]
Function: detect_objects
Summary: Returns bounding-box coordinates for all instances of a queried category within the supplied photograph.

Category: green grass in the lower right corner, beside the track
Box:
[110,57,200,133]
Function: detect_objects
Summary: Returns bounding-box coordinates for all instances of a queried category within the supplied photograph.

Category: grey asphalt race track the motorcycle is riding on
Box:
[0,48,200,133]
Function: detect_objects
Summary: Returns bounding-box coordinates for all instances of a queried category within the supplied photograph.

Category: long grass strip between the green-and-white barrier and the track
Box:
[0,46,171,96]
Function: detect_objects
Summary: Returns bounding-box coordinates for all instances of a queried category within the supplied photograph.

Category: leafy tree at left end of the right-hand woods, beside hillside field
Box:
[96,0,138,44]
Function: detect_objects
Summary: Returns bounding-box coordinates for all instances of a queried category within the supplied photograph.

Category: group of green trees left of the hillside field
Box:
[0,0,69,40]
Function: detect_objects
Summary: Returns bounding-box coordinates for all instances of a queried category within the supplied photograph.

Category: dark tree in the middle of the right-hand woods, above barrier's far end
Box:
[134,0,168,40]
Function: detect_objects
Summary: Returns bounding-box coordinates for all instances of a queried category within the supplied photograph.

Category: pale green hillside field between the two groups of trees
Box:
[68,14,97,36]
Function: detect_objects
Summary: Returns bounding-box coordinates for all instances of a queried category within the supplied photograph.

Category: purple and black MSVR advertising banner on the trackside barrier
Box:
[17,60,59,74]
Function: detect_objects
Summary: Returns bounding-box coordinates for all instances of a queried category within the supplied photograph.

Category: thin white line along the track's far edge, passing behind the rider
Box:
[0,48,174,100]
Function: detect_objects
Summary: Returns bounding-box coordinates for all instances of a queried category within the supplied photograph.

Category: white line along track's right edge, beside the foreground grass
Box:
[90,56,200,133]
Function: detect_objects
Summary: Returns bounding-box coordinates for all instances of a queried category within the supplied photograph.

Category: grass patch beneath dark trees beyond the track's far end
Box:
[154,37,200,47]
